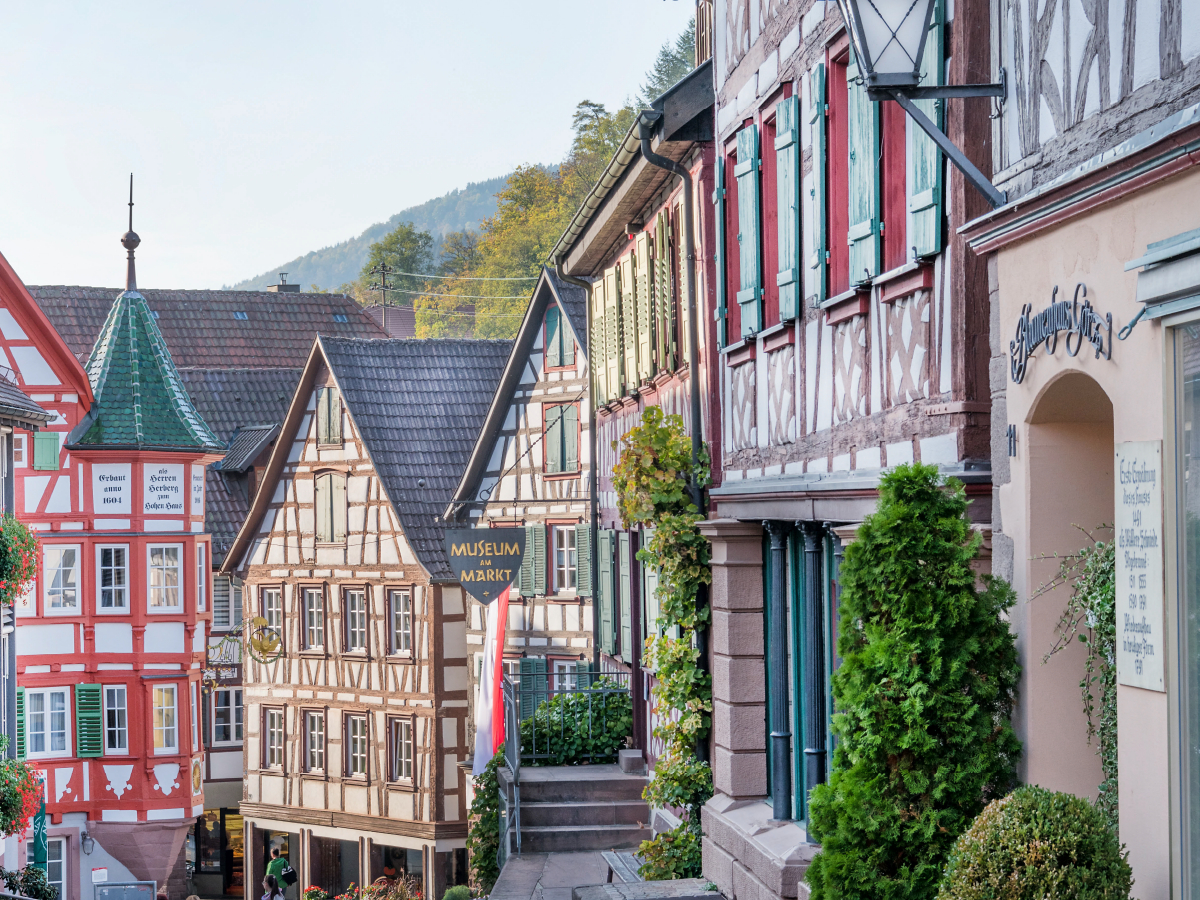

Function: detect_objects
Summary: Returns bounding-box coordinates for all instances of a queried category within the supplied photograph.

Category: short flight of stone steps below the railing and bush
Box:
[500,766,653,853]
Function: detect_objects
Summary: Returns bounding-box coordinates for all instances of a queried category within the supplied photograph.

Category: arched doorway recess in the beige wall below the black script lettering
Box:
[1019,372,1114,799]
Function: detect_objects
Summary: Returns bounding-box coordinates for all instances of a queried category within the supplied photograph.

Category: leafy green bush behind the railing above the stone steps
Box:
[521,678,634,766]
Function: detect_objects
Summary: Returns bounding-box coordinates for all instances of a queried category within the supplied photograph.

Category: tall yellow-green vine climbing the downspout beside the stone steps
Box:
[613,407,713,880]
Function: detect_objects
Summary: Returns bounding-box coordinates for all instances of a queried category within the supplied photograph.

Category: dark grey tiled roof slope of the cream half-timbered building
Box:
[320,337,512,578]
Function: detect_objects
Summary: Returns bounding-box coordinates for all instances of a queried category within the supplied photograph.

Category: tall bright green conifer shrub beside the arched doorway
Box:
[808,463,1021,900]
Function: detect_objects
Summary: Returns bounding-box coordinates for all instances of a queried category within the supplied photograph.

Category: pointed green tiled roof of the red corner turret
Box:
[67,290,224,452]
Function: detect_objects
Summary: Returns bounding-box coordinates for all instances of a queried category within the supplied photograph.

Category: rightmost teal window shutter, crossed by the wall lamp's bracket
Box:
[906,4,946,257]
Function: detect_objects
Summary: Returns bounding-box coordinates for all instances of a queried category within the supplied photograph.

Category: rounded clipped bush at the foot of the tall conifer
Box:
[937,785,1133,900]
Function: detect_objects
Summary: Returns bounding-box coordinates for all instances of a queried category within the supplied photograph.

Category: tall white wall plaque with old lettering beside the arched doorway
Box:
[1116,440,1166,691]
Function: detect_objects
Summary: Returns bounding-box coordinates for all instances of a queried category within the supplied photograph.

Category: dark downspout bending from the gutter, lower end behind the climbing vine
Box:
[637,109,709,762]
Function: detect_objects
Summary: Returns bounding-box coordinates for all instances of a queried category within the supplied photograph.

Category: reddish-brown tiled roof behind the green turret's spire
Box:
[29,284,388,368]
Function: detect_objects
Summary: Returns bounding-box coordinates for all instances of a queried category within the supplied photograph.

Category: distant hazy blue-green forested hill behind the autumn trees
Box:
[226,174,513,290]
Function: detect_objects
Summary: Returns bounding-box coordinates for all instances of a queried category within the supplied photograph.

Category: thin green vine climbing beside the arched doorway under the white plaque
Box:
[1030,526,1117,832]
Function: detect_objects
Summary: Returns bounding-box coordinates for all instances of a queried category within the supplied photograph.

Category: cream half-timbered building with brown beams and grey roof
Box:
[227,338,511,896]
